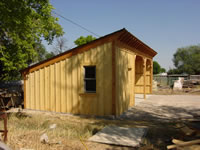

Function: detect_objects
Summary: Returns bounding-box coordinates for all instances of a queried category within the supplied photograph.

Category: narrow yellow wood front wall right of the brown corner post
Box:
[116,47,135,115]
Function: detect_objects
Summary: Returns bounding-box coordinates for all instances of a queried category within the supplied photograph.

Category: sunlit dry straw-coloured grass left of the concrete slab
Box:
[1,109,145,150]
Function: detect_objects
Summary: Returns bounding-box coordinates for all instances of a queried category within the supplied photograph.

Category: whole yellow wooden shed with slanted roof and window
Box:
[22,29,157,116]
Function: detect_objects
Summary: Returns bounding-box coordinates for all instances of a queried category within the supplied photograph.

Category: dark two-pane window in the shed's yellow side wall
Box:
[84,66,96,93]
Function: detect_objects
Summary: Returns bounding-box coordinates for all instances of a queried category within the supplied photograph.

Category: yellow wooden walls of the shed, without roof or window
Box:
[23,42,151,116]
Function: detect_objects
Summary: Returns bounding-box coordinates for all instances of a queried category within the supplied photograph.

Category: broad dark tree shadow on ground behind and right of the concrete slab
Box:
[85,106,200,150]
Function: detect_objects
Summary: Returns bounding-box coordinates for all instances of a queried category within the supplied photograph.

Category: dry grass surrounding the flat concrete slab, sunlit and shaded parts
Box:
[1,111,198,150]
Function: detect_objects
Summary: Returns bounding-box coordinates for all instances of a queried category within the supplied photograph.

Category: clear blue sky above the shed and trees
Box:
[48,0,200,70]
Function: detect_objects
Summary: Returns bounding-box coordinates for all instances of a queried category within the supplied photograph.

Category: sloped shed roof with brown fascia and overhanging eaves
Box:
[21,29,157,78]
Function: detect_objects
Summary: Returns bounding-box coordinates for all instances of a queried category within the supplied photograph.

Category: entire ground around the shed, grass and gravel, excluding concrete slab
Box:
[1,95,200,150]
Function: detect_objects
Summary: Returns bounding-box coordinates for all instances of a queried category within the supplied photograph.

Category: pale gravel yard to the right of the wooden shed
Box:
[120,95,200,121]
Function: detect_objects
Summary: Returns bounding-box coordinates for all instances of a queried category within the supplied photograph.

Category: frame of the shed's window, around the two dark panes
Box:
[83,65,97,93]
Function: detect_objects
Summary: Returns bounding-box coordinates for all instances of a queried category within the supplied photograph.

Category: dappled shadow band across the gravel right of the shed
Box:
[119,105,200,122]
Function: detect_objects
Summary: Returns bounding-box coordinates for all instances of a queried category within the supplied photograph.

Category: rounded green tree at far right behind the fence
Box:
[168,45,200,74]
